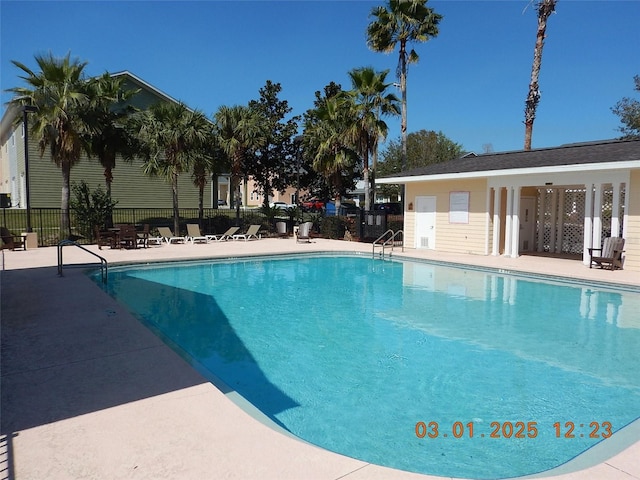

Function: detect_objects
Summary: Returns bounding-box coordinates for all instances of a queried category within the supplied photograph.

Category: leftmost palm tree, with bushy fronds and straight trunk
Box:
[8,53,90,238]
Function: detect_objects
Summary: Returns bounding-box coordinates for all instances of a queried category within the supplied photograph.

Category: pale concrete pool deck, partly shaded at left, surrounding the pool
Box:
[0,239,640,480]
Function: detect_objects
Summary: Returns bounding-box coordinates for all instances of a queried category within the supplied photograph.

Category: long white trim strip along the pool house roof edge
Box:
[376,160,640,184]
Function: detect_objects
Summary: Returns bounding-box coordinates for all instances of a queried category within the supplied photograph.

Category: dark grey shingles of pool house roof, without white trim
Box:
[387,140,640,178]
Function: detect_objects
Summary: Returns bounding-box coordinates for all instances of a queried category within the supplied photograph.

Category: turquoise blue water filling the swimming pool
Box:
[96,256,640,479]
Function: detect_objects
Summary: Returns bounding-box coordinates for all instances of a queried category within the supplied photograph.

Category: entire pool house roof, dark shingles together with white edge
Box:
[379,140,640,183]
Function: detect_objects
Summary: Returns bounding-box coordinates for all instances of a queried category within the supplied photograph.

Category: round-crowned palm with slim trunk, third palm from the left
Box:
[131,102,212,235]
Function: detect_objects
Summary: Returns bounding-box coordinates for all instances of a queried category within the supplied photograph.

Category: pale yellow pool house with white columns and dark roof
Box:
[378,140,640,272]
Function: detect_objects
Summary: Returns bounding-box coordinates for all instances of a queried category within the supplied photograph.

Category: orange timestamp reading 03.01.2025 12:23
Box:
[415,421,613,438]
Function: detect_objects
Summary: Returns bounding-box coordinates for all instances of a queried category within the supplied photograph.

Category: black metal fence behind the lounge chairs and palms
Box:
[0,208,403,247]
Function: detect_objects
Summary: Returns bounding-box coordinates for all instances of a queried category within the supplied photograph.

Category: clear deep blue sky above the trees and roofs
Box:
[0,0,640,152]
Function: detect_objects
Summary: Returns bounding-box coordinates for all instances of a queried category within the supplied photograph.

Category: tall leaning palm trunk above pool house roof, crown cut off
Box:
[524,0,557,150]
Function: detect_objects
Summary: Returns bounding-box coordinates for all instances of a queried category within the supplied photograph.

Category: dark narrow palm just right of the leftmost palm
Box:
[85,73,139,202]
